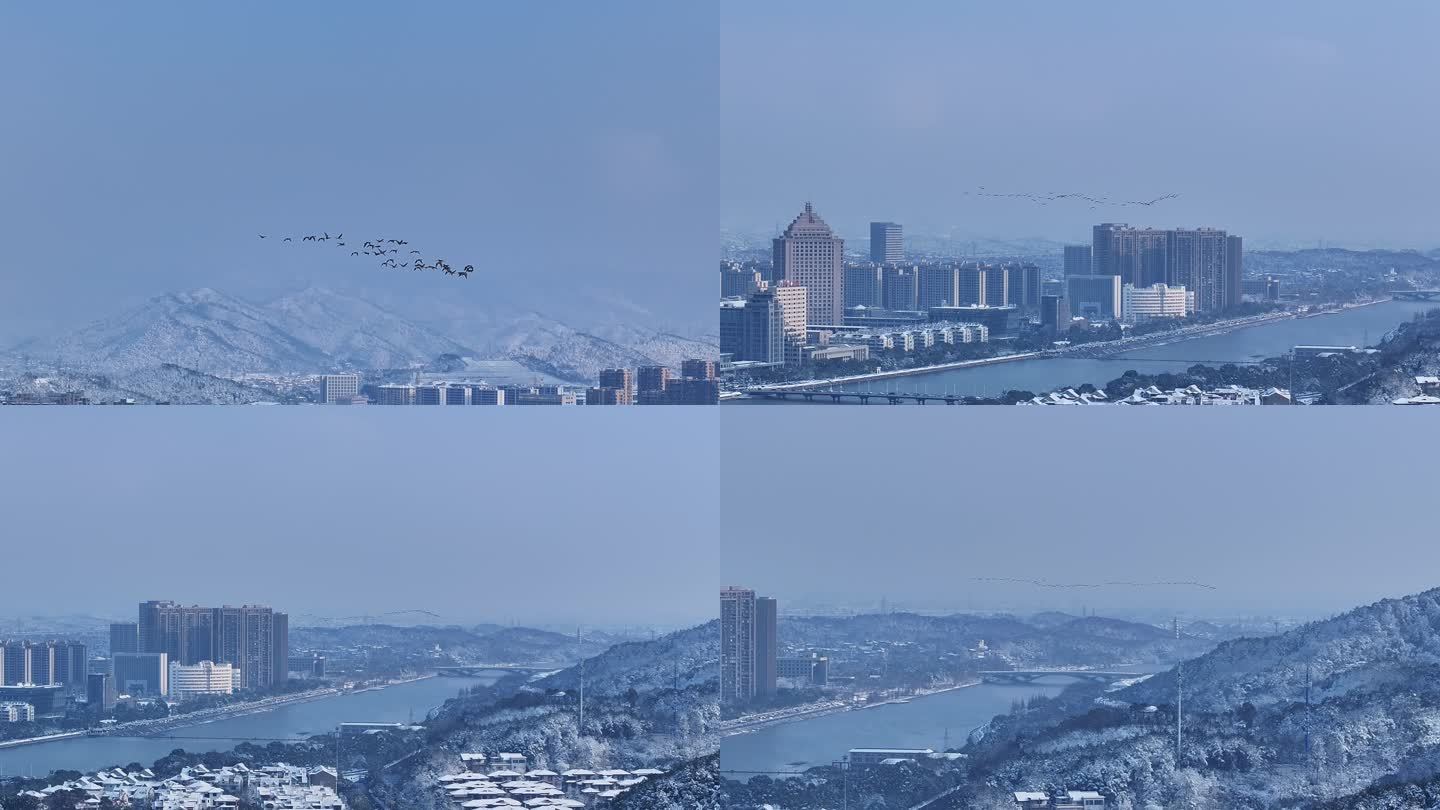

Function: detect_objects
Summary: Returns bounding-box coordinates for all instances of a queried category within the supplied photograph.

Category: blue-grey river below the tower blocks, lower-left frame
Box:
[0,668,495,777]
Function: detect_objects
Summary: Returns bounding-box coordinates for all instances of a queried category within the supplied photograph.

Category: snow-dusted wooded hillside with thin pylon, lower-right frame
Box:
[971,589,1440,809]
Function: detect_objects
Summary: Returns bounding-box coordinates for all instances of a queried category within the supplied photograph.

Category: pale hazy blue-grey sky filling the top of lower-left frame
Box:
[0,408,719,626]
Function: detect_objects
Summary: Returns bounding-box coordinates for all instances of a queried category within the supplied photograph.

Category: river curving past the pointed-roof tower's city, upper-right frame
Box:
[742,301,1437,404]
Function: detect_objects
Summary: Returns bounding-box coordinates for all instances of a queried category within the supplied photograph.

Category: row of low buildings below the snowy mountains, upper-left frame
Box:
[320,359,720,405]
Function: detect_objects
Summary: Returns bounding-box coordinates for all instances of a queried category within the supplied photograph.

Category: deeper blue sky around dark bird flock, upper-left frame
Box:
[0,0,719,344]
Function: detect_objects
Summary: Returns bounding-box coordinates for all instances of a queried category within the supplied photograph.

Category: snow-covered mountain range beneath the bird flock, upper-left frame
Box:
[0,287,719,402]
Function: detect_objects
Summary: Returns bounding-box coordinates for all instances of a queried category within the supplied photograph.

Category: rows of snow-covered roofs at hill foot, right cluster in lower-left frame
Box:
[439,752,665,810]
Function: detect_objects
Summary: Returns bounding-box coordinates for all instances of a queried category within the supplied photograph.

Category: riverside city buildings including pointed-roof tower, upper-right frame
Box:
[720,203,1249,370]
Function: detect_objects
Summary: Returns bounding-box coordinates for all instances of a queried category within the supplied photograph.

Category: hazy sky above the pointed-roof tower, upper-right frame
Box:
[720,0,1440,248]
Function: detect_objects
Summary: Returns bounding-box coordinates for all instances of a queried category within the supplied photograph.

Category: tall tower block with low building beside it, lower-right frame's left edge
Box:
[720,585,829,703]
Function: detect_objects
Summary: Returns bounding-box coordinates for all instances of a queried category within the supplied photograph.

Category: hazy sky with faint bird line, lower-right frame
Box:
[720,406,1440,615]
